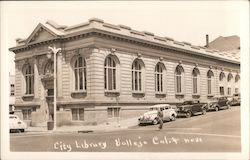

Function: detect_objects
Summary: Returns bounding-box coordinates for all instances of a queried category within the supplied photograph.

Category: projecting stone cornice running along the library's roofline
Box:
[10,24,240,64]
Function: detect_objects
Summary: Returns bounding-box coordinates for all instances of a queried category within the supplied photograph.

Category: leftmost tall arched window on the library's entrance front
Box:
[24,64,34,94]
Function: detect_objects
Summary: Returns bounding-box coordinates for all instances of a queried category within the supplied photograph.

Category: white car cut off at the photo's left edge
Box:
[9,114,27,132]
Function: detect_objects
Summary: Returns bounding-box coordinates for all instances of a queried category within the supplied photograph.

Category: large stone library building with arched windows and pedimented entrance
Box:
[10,18,240,126]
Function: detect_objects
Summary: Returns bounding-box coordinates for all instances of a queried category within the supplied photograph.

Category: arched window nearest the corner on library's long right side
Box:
[104,56,117,91]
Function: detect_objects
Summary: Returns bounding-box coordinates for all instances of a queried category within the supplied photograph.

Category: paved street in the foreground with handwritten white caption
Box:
[10,107,241,152]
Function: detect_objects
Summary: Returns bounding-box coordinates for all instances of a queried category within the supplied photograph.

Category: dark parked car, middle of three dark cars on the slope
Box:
[208,96,230,111]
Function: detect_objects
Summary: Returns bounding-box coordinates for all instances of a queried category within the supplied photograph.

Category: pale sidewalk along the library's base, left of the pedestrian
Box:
[26,117,138,133]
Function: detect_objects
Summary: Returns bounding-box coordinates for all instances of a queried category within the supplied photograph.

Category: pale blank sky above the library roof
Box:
[1,1,243,74]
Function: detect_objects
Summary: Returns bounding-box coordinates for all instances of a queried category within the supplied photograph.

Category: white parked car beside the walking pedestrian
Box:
[138,104,177,125]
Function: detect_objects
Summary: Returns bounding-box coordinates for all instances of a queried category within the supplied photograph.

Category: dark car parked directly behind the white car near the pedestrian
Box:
[177,100,207,118]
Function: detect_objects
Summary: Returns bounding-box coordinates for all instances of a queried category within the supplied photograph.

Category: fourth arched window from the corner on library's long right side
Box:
[175,65,184,93]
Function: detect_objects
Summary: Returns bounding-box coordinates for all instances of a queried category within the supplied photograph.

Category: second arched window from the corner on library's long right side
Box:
[132,59,144,92]
